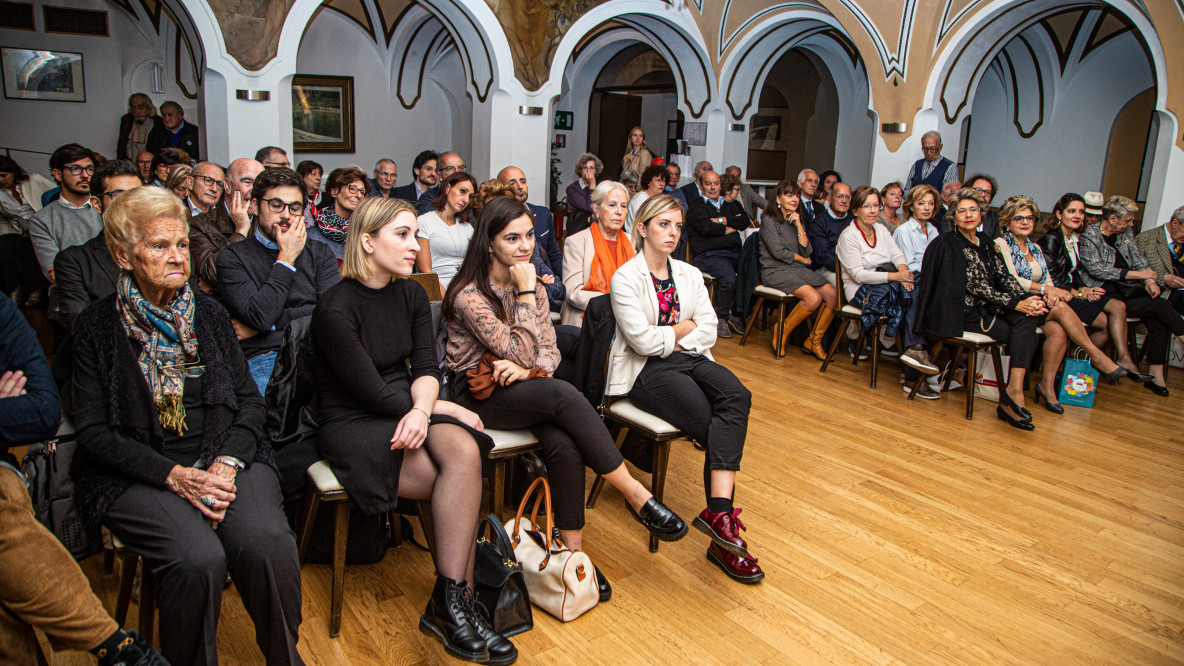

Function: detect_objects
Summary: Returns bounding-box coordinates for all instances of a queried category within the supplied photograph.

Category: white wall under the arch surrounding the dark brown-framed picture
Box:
[293,9,473,177]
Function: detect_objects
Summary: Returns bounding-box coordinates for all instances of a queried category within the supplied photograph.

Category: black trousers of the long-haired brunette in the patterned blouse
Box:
[453,376,625,530]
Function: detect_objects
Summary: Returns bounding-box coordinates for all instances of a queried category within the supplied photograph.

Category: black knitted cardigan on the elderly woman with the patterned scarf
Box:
[71,294,276,524]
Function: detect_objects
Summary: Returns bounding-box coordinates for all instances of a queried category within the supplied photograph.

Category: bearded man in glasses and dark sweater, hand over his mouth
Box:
[217,168,341,393]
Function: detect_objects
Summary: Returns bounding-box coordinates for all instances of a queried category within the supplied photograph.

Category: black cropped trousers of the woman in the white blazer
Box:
[629,352,752,499]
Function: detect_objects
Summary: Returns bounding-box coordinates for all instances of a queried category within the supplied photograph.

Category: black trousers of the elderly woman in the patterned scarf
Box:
[107,465,303,666]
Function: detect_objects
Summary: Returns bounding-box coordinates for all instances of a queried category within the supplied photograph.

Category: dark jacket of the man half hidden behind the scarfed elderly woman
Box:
[53,232,120,333]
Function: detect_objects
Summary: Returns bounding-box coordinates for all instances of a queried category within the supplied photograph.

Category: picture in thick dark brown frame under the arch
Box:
[292,73,354,153]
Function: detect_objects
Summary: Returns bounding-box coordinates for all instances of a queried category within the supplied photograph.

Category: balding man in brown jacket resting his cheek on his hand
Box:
[189,158,263,293]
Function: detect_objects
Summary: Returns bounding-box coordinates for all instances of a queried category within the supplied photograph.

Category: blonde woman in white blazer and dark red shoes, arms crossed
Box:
[606,194,765,583]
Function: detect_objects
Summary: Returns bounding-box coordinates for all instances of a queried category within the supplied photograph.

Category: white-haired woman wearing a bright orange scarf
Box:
[560,180,633,326]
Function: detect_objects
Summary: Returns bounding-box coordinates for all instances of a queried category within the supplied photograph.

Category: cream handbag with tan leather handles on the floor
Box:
[506,478,600,622]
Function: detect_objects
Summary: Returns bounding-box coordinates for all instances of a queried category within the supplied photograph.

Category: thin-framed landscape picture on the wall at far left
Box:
[0,46,86,102]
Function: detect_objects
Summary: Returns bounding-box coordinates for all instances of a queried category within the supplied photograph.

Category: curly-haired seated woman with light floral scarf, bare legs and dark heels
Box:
[995,194,1146,414]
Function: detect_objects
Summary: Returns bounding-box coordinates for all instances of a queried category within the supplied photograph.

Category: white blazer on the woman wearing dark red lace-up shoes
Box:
[605,252,719,396]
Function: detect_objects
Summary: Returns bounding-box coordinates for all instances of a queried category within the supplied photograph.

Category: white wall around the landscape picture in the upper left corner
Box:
[0,0,200,175]
